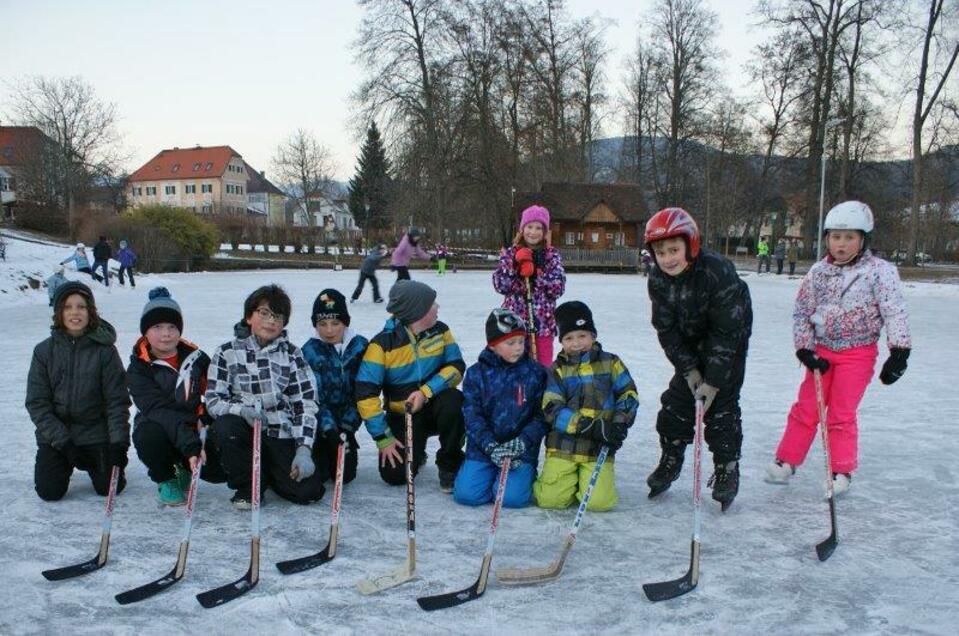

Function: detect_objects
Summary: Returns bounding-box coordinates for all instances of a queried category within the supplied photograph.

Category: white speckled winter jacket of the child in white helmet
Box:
[793,250,912,351]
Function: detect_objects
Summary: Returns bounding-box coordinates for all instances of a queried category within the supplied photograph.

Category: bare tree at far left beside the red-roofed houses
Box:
[11,75,126,239]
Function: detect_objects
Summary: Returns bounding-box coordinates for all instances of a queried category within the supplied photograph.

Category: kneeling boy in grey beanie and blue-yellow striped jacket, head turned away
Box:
[356,280,466,493]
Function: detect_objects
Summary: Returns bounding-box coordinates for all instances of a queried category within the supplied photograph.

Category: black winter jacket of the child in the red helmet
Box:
[648,249,753,389]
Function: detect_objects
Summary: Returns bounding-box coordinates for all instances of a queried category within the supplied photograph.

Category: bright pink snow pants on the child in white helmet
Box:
[776,343,879,473]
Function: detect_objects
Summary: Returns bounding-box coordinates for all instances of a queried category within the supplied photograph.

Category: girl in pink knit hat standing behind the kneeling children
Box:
[493,205,566,367]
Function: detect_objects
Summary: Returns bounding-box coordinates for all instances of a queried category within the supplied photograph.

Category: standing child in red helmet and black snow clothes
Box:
[645,208,753,510]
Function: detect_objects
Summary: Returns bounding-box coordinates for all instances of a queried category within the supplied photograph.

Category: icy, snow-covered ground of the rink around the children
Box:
[0,235,959,634]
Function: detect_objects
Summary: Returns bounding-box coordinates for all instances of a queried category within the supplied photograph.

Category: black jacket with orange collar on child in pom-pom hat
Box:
[127,336,210,457]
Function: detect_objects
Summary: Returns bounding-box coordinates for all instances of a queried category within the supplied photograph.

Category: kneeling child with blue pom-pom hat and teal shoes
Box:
[127,287,226,506]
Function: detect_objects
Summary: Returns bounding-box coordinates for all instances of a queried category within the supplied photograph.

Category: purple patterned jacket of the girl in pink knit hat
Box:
[493,245,566,336]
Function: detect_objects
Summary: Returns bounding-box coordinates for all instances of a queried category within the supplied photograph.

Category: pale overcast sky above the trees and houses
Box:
[0,0,880,179]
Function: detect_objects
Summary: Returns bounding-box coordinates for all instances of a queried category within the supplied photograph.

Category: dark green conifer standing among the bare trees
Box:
[349,122,391,236]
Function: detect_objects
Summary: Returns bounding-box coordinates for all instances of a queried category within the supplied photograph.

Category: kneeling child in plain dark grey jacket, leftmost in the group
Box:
[26,281,130,501]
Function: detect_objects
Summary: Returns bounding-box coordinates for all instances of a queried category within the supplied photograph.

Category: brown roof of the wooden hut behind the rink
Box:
[513,182,649,223]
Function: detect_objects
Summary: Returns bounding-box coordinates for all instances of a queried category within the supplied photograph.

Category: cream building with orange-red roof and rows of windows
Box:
[130,146,253,214]
